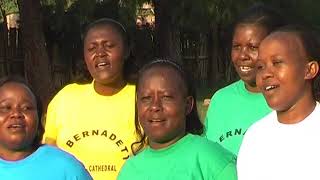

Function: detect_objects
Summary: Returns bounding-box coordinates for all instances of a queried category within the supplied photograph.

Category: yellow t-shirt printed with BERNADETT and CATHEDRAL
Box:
[44,83,136,180]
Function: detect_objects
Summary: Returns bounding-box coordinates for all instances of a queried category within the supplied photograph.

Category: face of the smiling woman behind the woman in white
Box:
[231,24,267,91]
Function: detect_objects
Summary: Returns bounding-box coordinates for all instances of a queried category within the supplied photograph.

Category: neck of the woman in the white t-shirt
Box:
[277,95,317,124]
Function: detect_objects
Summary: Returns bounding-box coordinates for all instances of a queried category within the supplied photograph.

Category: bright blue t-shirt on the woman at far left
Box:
[0,145,92,180]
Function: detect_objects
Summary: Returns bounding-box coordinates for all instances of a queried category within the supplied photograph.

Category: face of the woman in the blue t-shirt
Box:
[0,82,39,151]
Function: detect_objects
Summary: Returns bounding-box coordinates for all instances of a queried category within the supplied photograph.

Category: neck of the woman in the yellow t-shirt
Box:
[94,80,126,96]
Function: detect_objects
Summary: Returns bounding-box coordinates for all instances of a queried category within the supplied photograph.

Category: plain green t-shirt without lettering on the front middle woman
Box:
[118,134,237,180]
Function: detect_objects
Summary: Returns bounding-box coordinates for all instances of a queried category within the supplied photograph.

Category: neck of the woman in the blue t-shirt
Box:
[0,148,36,161]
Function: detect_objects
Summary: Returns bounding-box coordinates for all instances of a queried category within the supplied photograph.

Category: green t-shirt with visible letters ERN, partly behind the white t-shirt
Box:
[205,80,271,155]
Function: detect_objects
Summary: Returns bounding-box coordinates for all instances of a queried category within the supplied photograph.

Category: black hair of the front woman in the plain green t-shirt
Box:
[131,59,204,154]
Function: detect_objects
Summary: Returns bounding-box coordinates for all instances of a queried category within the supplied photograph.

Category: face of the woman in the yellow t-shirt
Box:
[84,24,126,85]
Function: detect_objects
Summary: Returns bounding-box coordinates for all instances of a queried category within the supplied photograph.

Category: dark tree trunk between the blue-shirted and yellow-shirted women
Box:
[18,0,53,107]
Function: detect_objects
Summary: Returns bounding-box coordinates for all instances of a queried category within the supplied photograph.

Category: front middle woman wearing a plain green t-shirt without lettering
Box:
[118,60,237,180]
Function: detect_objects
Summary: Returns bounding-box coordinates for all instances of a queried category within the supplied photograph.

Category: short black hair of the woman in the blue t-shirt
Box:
[0,75,44,148]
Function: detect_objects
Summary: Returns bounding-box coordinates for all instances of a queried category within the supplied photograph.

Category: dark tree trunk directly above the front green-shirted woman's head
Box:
[154,0,182,63]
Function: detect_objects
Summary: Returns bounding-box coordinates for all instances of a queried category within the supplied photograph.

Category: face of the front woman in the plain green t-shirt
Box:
[137,67,193,149]
